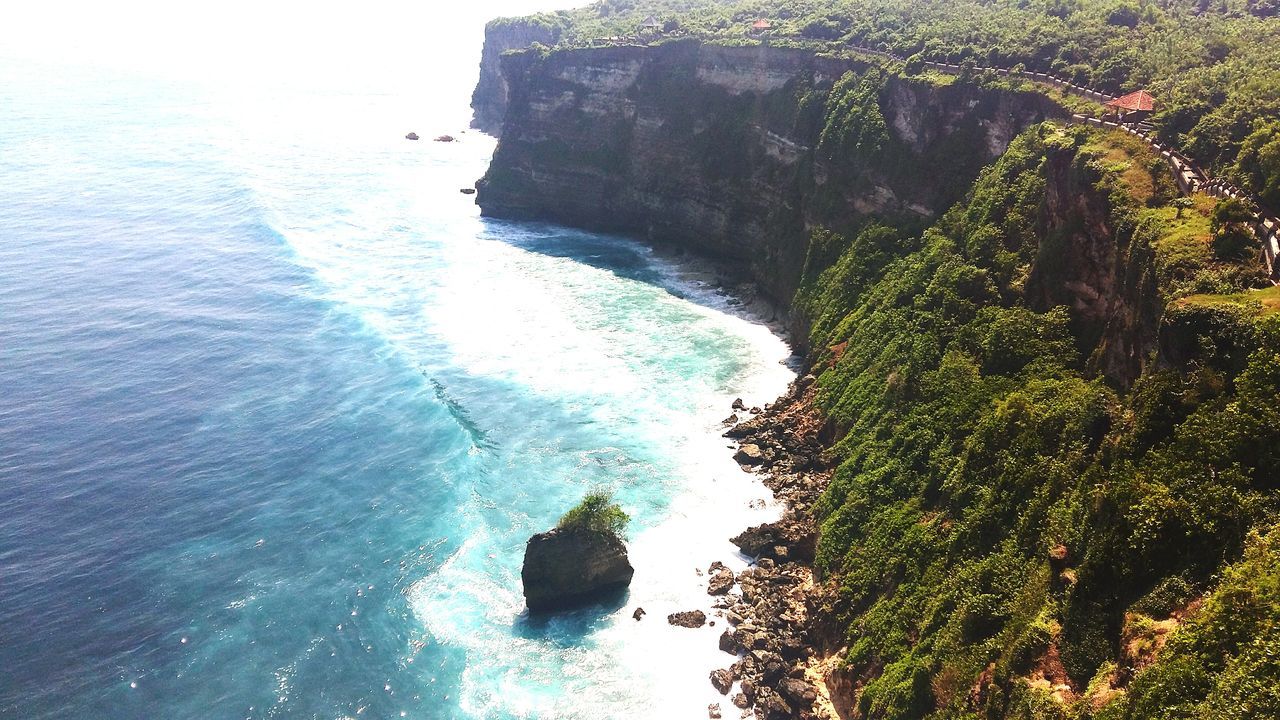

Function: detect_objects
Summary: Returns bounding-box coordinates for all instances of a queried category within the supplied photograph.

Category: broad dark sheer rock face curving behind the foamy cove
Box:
[476,42,1053,304]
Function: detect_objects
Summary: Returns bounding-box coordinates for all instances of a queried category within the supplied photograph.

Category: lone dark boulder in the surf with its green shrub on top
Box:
[520,493,635,612]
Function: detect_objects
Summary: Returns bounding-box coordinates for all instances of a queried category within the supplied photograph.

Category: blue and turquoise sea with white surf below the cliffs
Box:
[0,51,792,719]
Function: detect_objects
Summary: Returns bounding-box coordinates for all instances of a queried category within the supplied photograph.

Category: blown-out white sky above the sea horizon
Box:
[0,0,585,87]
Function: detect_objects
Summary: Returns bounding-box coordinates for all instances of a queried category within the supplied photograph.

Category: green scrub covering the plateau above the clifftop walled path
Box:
[495,0,1280,210]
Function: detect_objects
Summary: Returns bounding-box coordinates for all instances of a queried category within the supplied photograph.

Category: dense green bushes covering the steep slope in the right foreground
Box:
[797,126,1280,720]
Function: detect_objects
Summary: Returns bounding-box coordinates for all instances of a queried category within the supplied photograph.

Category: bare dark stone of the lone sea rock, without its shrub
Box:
[520,529,635,611]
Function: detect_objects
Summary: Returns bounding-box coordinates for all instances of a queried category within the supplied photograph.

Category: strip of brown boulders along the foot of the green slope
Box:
[708,375,840,720]
